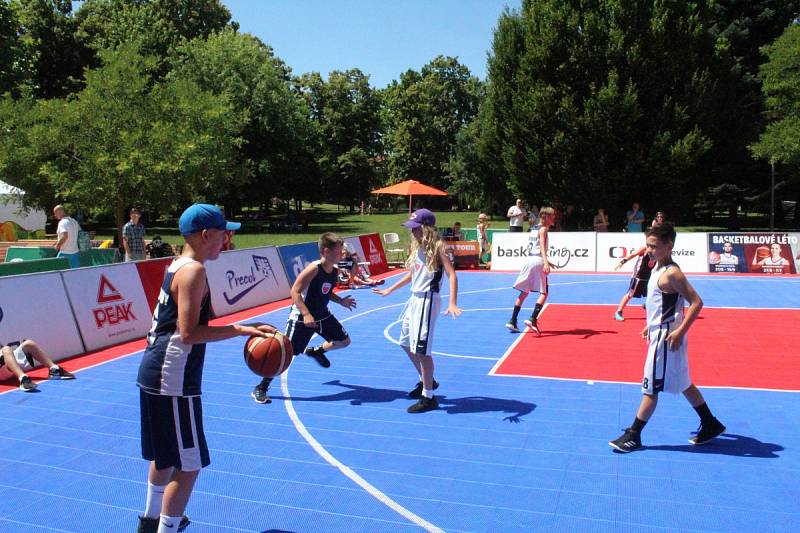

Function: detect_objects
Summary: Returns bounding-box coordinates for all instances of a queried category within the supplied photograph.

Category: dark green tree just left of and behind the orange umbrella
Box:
[298,69,382,211]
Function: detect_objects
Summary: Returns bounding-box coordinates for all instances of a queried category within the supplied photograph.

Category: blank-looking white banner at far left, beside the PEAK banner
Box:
[0,272,84,361]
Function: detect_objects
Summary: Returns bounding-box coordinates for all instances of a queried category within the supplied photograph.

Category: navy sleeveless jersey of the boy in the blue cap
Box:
[137,257,211,396]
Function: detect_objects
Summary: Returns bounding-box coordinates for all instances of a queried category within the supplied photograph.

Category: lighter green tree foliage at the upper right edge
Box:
[752,24,800,165]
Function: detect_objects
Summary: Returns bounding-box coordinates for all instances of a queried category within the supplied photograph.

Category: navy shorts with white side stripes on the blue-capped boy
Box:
[139,389,211,472]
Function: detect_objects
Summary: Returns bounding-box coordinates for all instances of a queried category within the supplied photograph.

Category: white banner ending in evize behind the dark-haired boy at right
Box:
[597,232,707,272]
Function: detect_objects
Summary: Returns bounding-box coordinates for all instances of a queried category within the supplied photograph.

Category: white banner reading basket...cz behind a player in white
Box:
[492,232,596,272]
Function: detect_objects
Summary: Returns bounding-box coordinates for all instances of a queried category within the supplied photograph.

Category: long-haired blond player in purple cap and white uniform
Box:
[372,209,461,413]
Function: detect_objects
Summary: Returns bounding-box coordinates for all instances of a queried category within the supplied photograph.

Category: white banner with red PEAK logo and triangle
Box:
[61,263,152,351]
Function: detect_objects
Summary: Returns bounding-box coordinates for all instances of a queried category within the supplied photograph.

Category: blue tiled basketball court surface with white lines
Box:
[0,272,800,533]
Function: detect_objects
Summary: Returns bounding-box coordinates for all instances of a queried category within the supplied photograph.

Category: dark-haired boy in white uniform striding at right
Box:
[608,223,725,453]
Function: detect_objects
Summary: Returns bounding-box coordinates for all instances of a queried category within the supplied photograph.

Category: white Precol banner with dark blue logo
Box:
[205,247,289,316]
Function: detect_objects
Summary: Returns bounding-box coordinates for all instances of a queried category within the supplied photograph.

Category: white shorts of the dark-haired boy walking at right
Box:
[642,322,692,395]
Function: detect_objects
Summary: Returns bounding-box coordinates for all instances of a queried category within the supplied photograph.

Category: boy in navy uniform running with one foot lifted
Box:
[250,233,356,403]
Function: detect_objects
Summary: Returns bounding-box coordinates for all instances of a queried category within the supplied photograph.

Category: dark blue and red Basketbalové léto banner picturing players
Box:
[708,232,798,275]
